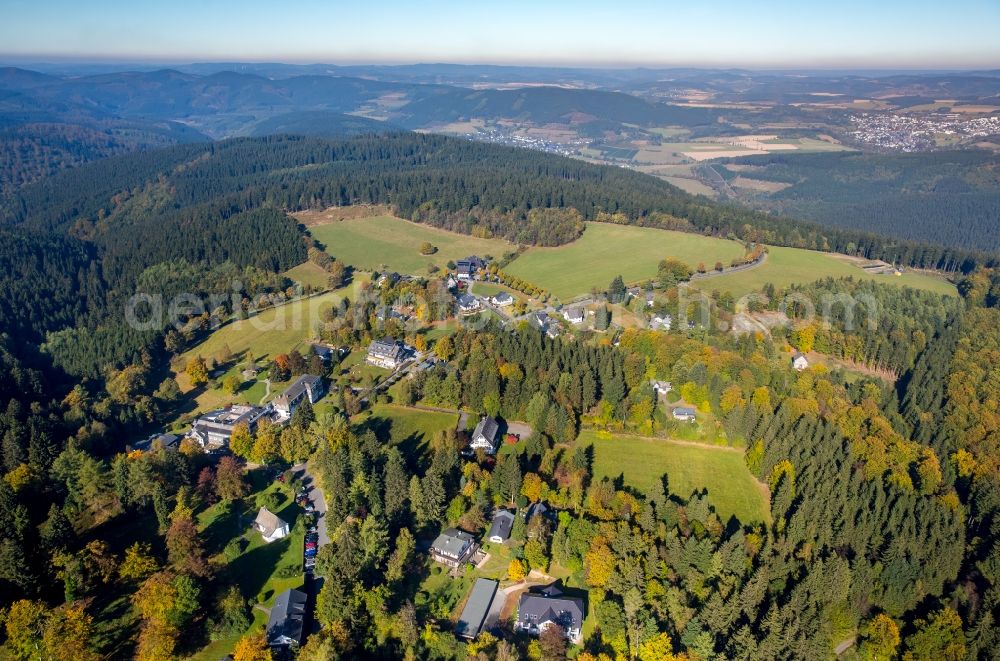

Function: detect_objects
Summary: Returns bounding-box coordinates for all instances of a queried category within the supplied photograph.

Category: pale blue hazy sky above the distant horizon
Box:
[0,0,1000,68]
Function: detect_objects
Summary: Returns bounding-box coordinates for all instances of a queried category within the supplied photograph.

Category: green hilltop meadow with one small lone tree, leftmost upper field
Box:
[309,216,515,275]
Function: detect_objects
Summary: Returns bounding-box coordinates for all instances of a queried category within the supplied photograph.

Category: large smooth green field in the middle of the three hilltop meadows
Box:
[505,223,743,300]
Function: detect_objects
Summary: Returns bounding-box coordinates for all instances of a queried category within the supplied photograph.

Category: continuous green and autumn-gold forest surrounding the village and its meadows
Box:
[0,134,1000,661]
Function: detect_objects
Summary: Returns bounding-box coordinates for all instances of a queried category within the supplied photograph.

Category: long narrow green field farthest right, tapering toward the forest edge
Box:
[694,247,956,296]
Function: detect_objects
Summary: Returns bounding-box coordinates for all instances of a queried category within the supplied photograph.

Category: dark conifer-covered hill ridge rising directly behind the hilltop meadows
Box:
[3,133,995,271]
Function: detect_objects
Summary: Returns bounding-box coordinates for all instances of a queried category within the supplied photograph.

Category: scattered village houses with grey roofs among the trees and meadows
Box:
[123,249,809,658]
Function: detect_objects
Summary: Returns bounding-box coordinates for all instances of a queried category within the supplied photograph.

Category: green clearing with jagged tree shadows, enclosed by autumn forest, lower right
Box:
[577,430,770,523]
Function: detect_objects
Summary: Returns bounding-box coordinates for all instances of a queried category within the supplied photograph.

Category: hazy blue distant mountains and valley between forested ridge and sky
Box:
[0,63,1000,186]
